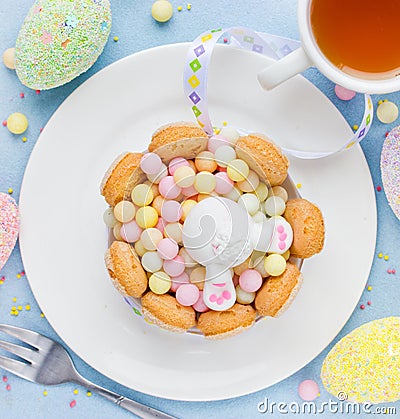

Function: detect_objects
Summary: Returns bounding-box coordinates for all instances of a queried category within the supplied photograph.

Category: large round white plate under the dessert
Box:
[20,44,376,400]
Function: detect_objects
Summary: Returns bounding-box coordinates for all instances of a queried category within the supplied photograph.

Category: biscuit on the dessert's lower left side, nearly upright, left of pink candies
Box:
[105,241,148,298]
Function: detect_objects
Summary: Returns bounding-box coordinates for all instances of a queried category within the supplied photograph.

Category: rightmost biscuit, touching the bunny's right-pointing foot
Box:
[283,198,325,259]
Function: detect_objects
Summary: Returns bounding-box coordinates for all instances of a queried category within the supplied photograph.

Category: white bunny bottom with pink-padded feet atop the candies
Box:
[183,197,293,311]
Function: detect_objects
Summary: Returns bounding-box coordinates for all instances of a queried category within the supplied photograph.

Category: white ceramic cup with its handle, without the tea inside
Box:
[258,0,400,94]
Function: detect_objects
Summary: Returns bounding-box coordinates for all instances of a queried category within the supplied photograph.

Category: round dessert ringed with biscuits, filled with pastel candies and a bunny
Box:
[101,122,325,339]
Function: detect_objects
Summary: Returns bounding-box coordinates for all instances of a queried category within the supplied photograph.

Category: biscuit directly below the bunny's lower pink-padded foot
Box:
[197,303,256,339]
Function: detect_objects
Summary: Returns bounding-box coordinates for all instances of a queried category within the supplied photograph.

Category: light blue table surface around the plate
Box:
[0,0,400,419]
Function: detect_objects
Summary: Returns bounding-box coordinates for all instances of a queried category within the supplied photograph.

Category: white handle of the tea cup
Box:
[257,47,313,90]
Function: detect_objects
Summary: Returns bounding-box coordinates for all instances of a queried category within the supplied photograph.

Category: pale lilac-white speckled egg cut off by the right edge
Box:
[381,126,400,219]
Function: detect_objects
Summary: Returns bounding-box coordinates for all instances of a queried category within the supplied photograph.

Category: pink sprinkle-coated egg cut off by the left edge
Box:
[0,193,19,270]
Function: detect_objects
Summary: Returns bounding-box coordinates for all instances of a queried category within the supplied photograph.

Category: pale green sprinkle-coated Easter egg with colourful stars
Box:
[15,0,111,90]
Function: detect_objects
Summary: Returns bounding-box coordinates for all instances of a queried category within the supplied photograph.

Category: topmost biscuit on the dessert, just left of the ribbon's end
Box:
[149,122,208,163]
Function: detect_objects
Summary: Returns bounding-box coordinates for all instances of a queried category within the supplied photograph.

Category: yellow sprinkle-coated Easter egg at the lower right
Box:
[321,317,400,403]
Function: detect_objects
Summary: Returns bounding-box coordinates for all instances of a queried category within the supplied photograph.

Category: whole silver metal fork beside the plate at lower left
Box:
[0,324,176,419]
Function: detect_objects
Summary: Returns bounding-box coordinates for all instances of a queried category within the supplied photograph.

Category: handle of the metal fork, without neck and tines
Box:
[73,376,177,419]
